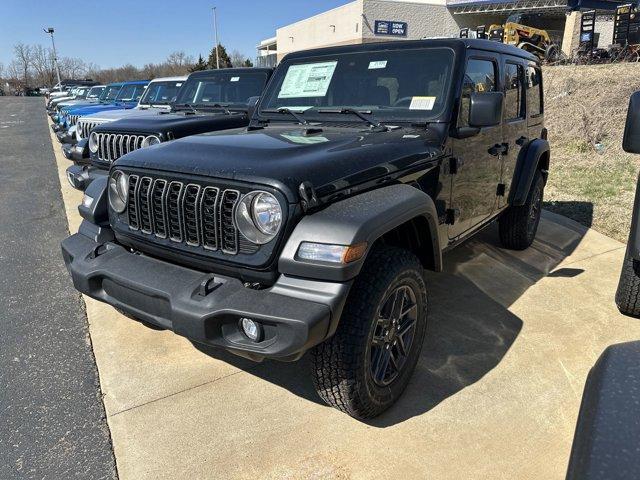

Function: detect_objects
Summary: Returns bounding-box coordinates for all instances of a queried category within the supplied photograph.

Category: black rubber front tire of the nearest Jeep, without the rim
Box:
[312,246,427,419]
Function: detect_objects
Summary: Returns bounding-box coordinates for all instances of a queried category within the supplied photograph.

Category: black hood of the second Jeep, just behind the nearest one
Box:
[95,112,249,138]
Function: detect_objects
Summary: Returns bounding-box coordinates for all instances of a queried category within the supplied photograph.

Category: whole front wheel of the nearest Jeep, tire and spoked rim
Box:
[313,247,427,419]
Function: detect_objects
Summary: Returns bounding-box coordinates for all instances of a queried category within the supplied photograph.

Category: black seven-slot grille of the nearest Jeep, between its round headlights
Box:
[124,175,244,255]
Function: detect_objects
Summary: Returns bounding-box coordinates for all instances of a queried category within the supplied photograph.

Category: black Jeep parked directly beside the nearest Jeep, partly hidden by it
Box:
[67,68,273,190]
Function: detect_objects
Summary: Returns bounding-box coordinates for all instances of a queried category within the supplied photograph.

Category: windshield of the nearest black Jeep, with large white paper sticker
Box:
[260,48,453,121]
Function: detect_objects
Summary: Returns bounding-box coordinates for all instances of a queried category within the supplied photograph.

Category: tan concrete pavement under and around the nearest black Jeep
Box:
[45,103,640,480]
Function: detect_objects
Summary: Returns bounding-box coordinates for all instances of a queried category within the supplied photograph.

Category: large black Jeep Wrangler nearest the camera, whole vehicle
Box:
[62,39,549,418]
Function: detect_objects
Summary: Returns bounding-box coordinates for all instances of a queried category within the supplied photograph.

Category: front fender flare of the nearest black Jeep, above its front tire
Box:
[278,184,442,282]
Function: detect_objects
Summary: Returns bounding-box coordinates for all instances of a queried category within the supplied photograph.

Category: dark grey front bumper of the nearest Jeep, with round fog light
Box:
[62,230,350,361]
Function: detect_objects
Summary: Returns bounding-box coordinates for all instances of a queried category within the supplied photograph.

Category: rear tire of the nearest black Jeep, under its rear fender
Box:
[498,170,544,250]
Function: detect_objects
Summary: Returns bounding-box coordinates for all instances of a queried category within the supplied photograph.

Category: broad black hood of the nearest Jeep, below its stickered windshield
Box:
[116,125,442,202]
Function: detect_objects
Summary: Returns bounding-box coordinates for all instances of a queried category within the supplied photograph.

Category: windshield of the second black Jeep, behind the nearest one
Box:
[176,71,267,108]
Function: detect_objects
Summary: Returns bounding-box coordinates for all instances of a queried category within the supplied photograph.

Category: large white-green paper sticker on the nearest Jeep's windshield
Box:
[278,60,338,98]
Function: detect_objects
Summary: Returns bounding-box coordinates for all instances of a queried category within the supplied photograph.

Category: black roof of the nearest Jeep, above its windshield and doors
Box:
[285,38,539,62]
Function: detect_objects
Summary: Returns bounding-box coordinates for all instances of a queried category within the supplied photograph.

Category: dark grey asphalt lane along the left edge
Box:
[0,97,116,480]
